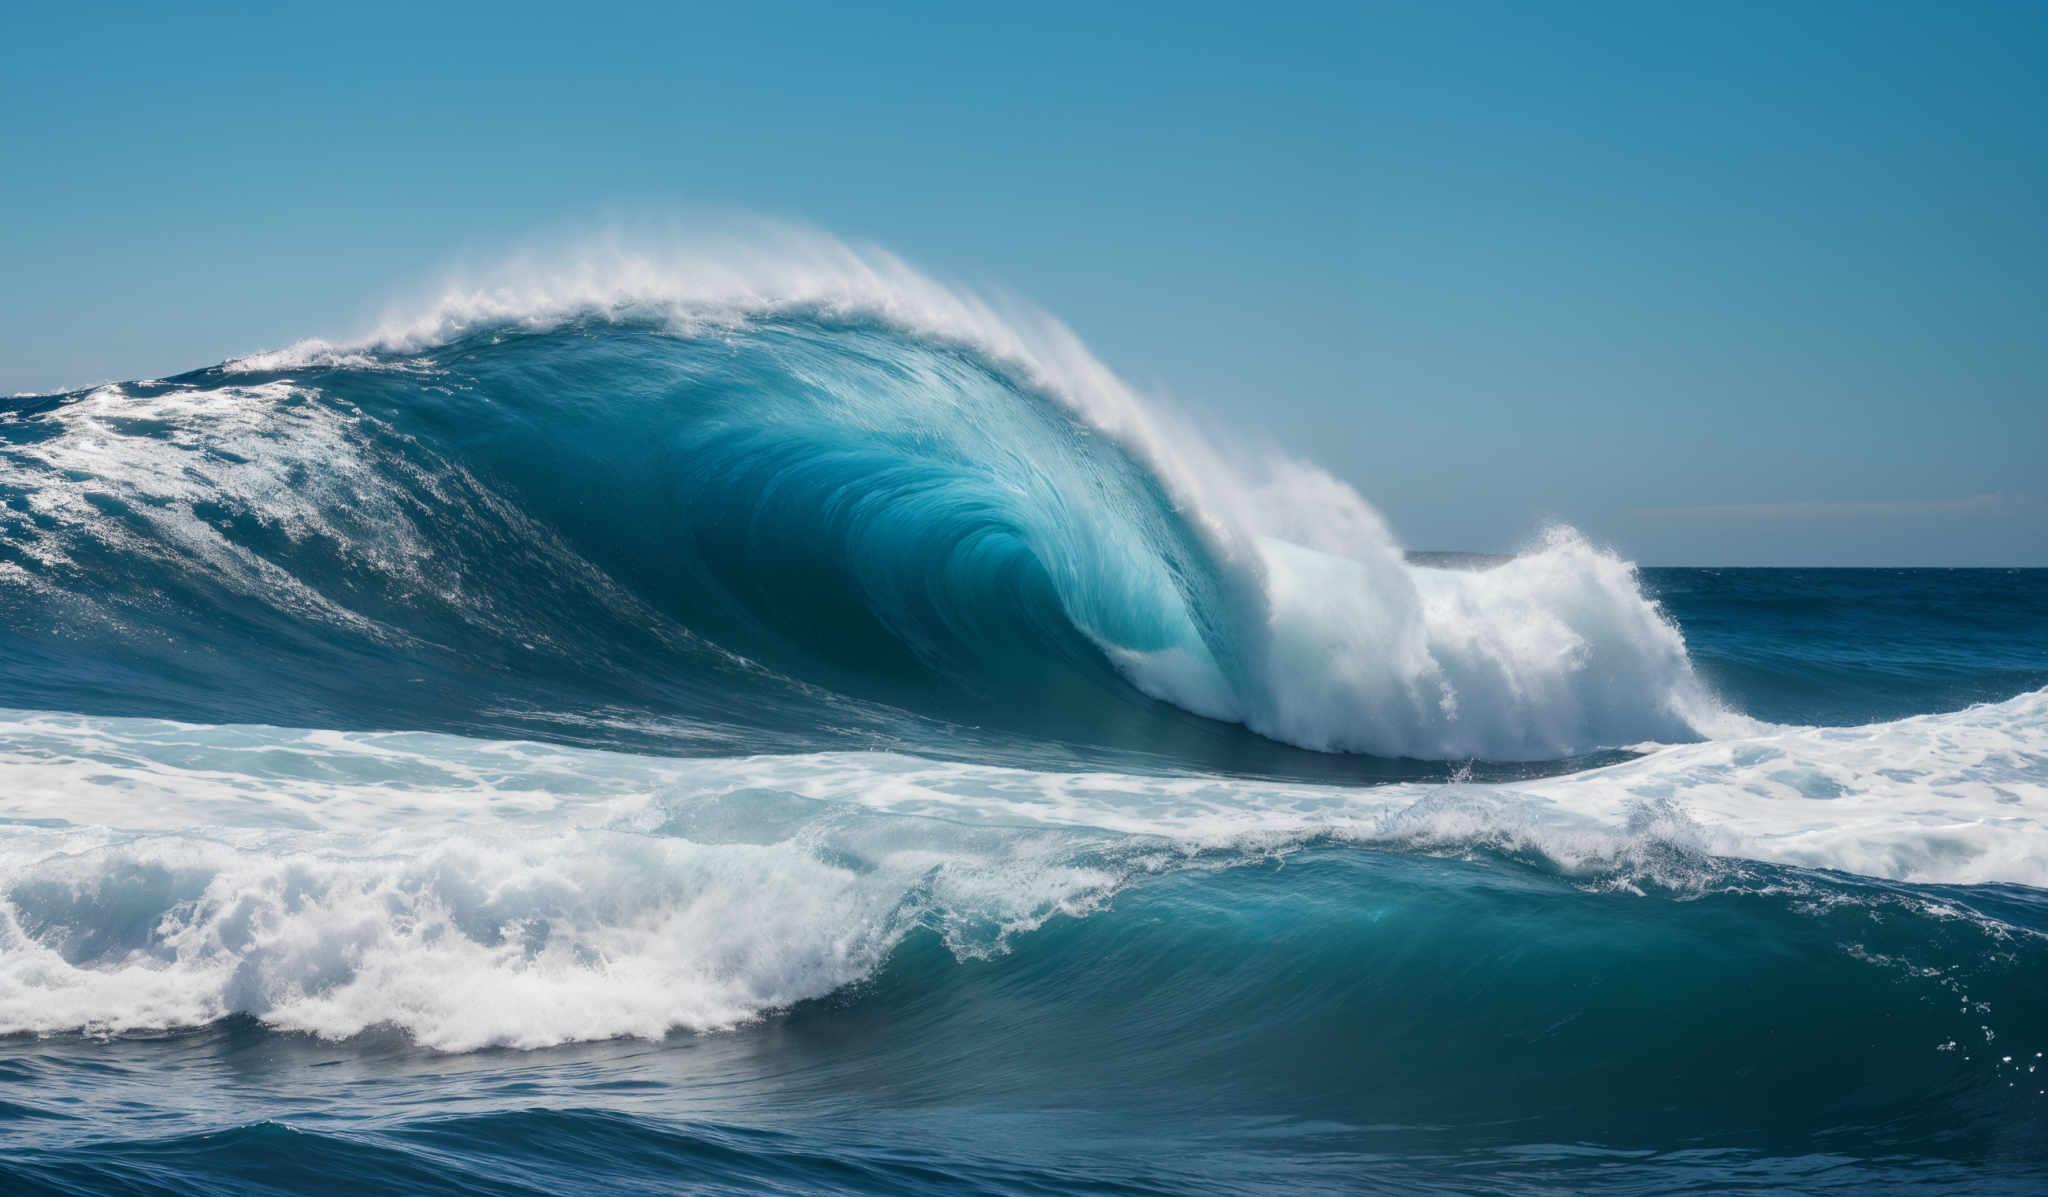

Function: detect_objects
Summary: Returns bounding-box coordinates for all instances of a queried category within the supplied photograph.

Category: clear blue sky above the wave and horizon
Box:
[0,0,2048,566]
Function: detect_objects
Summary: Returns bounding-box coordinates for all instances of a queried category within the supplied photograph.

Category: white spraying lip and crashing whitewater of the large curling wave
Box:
[199,240,1749,760]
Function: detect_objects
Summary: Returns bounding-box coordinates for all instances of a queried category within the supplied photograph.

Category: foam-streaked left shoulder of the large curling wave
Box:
[0,379,688,646]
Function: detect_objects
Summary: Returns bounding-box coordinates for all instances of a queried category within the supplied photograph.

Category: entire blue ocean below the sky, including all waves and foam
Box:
[0,254,2048,1195]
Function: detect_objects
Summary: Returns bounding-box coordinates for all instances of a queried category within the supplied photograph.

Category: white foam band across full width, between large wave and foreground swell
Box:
[0,691,2048,1049]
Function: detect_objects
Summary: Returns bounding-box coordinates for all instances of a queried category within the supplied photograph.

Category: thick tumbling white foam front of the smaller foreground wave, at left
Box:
[0,828,1112,1049]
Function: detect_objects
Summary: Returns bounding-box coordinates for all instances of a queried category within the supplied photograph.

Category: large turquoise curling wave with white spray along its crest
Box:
[0,244,1741,760]
